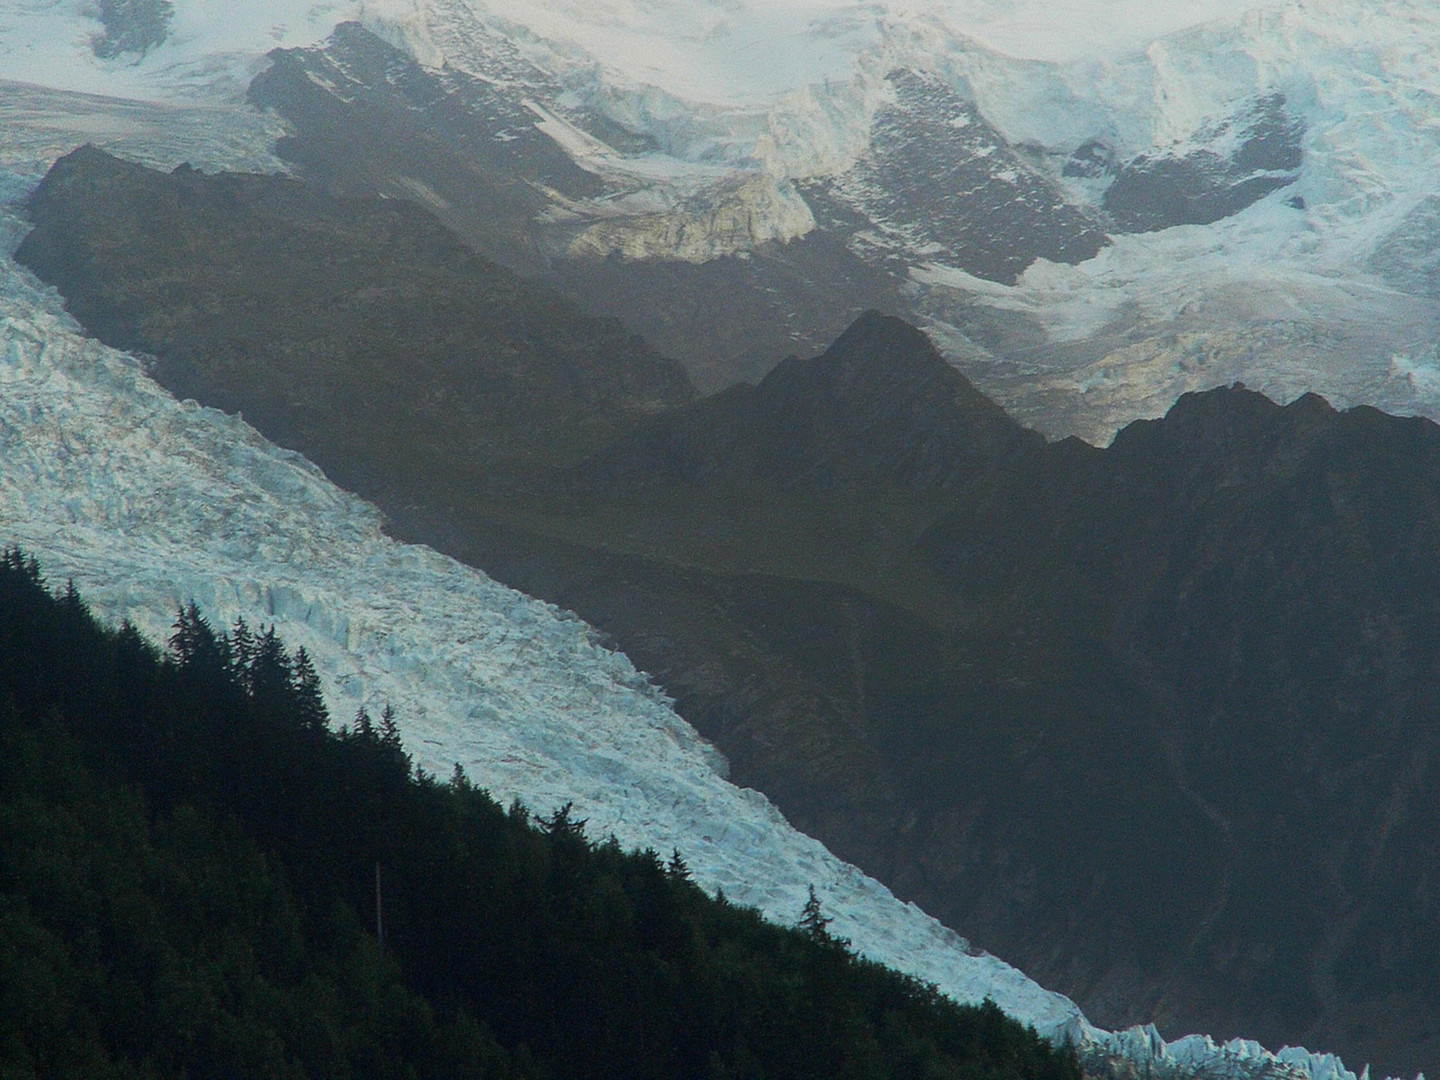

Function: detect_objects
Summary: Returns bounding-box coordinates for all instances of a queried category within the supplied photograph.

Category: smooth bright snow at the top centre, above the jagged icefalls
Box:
[367,0,1301,105]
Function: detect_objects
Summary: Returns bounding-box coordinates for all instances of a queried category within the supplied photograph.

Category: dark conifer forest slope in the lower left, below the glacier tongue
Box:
[0,552,1080,1080]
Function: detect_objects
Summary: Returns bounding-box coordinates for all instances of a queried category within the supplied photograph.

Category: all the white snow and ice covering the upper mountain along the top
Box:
[0,0,1440,442]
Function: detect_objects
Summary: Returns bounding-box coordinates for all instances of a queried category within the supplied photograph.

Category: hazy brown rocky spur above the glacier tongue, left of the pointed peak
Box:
[20,148,693,475]
